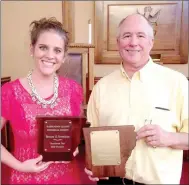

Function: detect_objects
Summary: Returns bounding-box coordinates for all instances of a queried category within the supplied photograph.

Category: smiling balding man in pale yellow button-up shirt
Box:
[85,14,189,184]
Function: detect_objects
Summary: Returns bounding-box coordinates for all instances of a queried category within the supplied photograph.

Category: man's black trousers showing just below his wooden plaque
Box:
[97,177,143,185]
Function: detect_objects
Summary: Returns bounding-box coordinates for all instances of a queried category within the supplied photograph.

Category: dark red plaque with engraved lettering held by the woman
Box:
[36,116,86,161]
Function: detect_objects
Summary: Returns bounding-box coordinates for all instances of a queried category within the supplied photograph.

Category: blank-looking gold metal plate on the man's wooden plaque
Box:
[90,130,121,166]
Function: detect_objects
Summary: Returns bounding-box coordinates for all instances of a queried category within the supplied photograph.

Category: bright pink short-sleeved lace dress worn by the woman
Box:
[1,77,83,184]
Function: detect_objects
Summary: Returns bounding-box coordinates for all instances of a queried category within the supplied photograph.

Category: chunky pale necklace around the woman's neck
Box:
[27,71,59,108]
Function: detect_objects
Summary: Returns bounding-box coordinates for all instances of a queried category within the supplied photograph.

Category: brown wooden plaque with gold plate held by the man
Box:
[83,125,136,177]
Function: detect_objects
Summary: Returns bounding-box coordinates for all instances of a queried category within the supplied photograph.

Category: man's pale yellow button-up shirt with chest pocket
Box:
[87,58,188,184]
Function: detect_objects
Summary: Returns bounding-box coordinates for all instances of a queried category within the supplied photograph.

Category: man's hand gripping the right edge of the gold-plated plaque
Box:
[137,124,170,147]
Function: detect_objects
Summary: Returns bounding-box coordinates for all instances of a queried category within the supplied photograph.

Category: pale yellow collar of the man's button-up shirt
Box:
[120,57,154,82]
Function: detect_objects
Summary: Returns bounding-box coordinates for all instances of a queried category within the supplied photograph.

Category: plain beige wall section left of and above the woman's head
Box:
[1,1,62,80]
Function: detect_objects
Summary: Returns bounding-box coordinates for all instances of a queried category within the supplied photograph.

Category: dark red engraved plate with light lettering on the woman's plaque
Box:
[43,120,72,152]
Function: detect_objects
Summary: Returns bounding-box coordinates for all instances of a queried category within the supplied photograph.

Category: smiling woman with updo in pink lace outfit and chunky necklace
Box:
[1,18,82,184]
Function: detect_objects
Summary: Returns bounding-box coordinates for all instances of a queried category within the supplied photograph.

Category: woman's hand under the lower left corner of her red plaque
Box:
[17,155,53,173]
